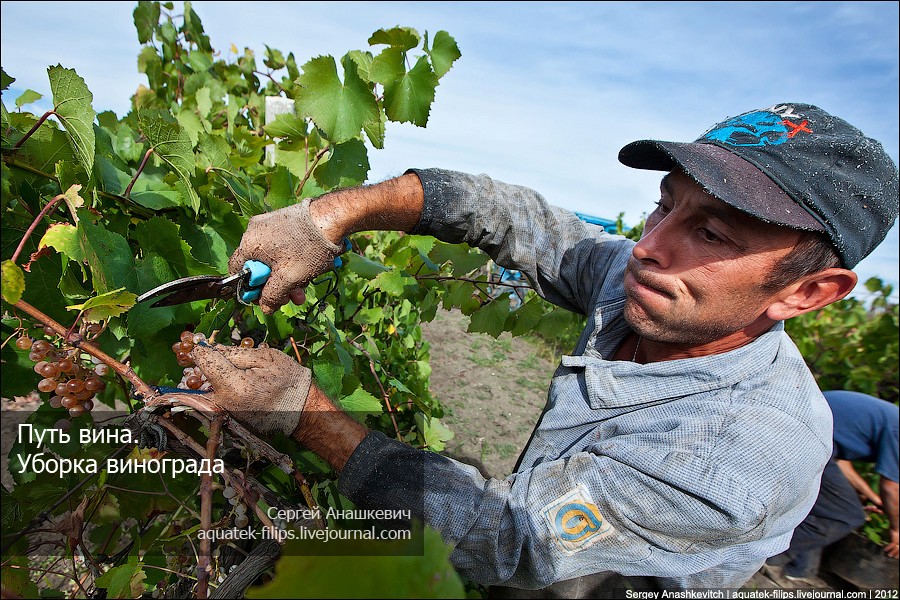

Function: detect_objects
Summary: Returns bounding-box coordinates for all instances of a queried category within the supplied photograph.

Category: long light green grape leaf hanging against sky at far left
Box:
[47,65,97,178]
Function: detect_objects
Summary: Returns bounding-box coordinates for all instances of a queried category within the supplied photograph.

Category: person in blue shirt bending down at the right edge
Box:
[766,390,900,587]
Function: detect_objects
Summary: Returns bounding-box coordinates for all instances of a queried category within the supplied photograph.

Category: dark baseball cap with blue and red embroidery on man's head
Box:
[619,103,900,269]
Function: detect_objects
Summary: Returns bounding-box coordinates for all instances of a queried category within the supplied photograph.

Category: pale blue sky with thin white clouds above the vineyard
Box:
[0,2,900,298]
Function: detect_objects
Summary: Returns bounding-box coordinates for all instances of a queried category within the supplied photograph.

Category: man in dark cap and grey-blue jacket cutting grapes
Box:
[186,104,898,597]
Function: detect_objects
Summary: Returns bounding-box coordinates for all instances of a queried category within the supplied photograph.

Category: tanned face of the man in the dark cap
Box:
[625,171,800,349]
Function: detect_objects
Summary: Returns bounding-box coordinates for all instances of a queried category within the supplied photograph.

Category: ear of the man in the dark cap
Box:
[766,268,859,321]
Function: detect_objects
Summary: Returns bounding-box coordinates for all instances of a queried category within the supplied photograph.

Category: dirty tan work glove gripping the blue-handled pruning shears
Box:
[229,198,341,316]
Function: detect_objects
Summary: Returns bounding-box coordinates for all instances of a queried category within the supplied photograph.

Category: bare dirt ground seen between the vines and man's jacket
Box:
[422,310,556,478]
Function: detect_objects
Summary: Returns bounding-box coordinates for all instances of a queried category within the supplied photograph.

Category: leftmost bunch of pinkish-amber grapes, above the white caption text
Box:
[16,324,109,417]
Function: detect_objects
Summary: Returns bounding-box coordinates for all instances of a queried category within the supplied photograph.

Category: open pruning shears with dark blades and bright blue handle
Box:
[137,260,272,308]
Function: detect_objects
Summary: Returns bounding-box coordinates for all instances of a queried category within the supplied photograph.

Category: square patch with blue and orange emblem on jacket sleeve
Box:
[541,484,615,554]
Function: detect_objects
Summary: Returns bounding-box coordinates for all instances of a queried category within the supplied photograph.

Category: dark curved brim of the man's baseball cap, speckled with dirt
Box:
[619,140,825,231]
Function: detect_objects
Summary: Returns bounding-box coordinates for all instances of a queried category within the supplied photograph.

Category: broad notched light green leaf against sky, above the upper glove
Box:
[296,56,378,144]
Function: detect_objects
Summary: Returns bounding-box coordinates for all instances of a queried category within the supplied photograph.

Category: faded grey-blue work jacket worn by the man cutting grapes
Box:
[339,169,832,589]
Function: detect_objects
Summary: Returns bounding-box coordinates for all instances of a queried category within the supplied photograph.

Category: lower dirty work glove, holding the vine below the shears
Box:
[191,344,312,437]
